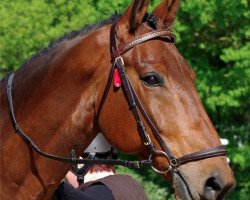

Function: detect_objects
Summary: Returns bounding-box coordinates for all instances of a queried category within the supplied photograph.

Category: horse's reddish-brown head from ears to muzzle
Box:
[98,0,234,199]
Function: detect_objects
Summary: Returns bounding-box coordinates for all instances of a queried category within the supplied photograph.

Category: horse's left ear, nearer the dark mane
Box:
[117,0,149,33]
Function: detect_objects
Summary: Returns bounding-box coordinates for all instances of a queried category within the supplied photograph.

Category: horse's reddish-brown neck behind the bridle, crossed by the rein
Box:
[1,24,110,199]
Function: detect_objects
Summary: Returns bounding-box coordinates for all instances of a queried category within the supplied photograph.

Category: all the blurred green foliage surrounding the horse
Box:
[0,0,250,200]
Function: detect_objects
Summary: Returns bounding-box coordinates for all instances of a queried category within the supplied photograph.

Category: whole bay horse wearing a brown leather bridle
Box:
[0,0,235,200]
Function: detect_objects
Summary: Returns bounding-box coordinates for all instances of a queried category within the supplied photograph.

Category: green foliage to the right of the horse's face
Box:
[176,0,250,199]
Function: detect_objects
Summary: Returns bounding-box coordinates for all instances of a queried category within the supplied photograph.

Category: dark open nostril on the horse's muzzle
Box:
[204,176,223,200]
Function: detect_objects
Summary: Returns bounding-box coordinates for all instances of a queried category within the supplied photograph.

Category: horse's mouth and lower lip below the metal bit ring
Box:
[173,172,197,200]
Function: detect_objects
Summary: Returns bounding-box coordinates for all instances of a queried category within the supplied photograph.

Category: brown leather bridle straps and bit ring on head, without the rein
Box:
[97,19,226,174]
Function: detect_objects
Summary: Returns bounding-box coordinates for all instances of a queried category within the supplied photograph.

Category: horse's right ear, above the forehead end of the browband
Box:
[152,0,180,29]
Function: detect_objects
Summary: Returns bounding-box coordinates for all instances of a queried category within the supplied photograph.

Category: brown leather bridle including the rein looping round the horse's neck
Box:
[6,18,226,173]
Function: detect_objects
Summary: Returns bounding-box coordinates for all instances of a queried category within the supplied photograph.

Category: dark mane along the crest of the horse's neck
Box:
[21,13,120,67]
